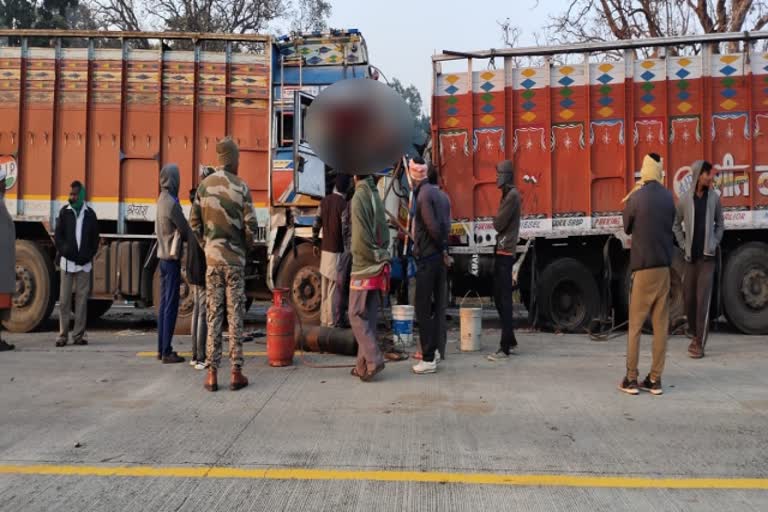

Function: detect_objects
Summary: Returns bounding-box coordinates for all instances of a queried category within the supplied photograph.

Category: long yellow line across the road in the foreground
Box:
[0,464,768,490]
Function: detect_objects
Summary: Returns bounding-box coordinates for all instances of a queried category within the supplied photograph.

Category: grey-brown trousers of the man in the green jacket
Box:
[349,290,384,375]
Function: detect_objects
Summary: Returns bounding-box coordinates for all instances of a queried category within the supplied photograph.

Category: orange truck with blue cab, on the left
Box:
[0,29,379,332]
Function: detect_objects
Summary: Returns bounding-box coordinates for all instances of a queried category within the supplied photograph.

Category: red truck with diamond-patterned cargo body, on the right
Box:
[432,32,768,334]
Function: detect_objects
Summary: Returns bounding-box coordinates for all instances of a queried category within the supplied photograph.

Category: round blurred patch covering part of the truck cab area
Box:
[305,79,414,175]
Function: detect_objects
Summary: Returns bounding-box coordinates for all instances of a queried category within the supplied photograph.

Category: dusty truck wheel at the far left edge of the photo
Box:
[3,240,57,332]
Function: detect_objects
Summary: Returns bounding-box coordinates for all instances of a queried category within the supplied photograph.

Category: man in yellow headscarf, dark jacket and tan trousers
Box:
[619,153,675,395]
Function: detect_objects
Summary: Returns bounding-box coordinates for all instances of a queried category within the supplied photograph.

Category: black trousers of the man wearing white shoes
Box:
[416,257,448,362]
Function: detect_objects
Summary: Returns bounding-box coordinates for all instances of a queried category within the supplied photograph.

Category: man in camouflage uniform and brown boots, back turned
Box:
[190,137,258,391]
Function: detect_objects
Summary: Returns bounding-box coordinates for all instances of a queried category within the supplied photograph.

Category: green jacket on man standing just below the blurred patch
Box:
[351,176,390,279]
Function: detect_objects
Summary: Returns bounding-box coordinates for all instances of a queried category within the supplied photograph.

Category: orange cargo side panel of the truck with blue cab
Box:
[0,48,270,233]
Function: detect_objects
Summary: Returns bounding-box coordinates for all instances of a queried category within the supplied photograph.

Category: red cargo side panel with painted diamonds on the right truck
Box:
[433,51,768,243]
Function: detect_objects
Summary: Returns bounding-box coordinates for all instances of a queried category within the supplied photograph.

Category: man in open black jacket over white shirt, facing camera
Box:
[54,181,99,347]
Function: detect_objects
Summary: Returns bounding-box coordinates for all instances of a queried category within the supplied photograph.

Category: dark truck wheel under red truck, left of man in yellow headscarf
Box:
[538,258,600,333]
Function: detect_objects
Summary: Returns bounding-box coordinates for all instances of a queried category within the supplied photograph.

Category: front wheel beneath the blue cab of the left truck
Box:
[275,244,321,325]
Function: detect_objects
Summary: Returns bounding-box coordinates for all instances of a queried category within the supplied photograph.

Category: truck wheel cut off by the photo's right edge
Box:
[722,242,768,334]
